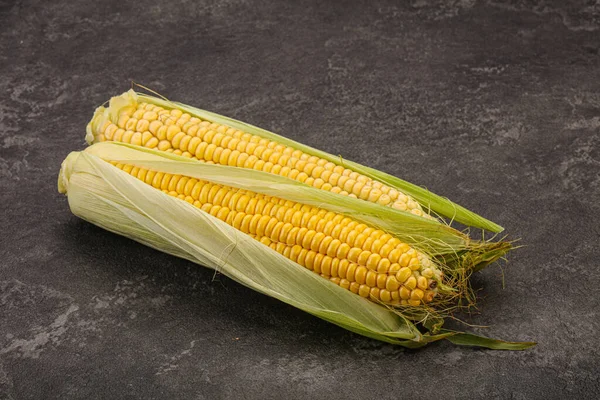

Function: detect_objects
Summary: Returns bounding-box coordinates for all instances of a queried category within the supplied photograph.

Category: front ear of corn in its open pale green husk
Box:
[59,143,534,350]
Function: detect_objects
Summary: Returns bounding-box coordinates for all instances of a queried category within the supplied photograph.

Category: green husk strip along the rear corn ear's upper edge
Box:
[86,90,503,232]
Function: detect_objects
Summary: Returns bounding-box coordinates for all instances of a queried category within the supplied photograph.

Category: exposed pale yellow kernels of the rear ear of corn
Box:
[94,103,431,218]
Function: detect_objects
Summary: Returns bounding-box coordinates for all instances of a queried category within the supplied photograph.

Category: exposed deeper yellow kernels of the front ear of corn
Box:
[112,162,442,306]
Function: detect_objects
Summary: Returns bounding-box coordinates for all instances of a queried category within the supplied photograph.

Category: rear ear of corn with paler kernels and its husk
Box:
[86,91,502,232]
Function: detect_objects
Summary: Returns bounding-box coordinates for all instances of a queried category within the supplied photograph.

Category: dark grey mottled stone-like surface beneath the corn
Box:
[0,0,600,399]
